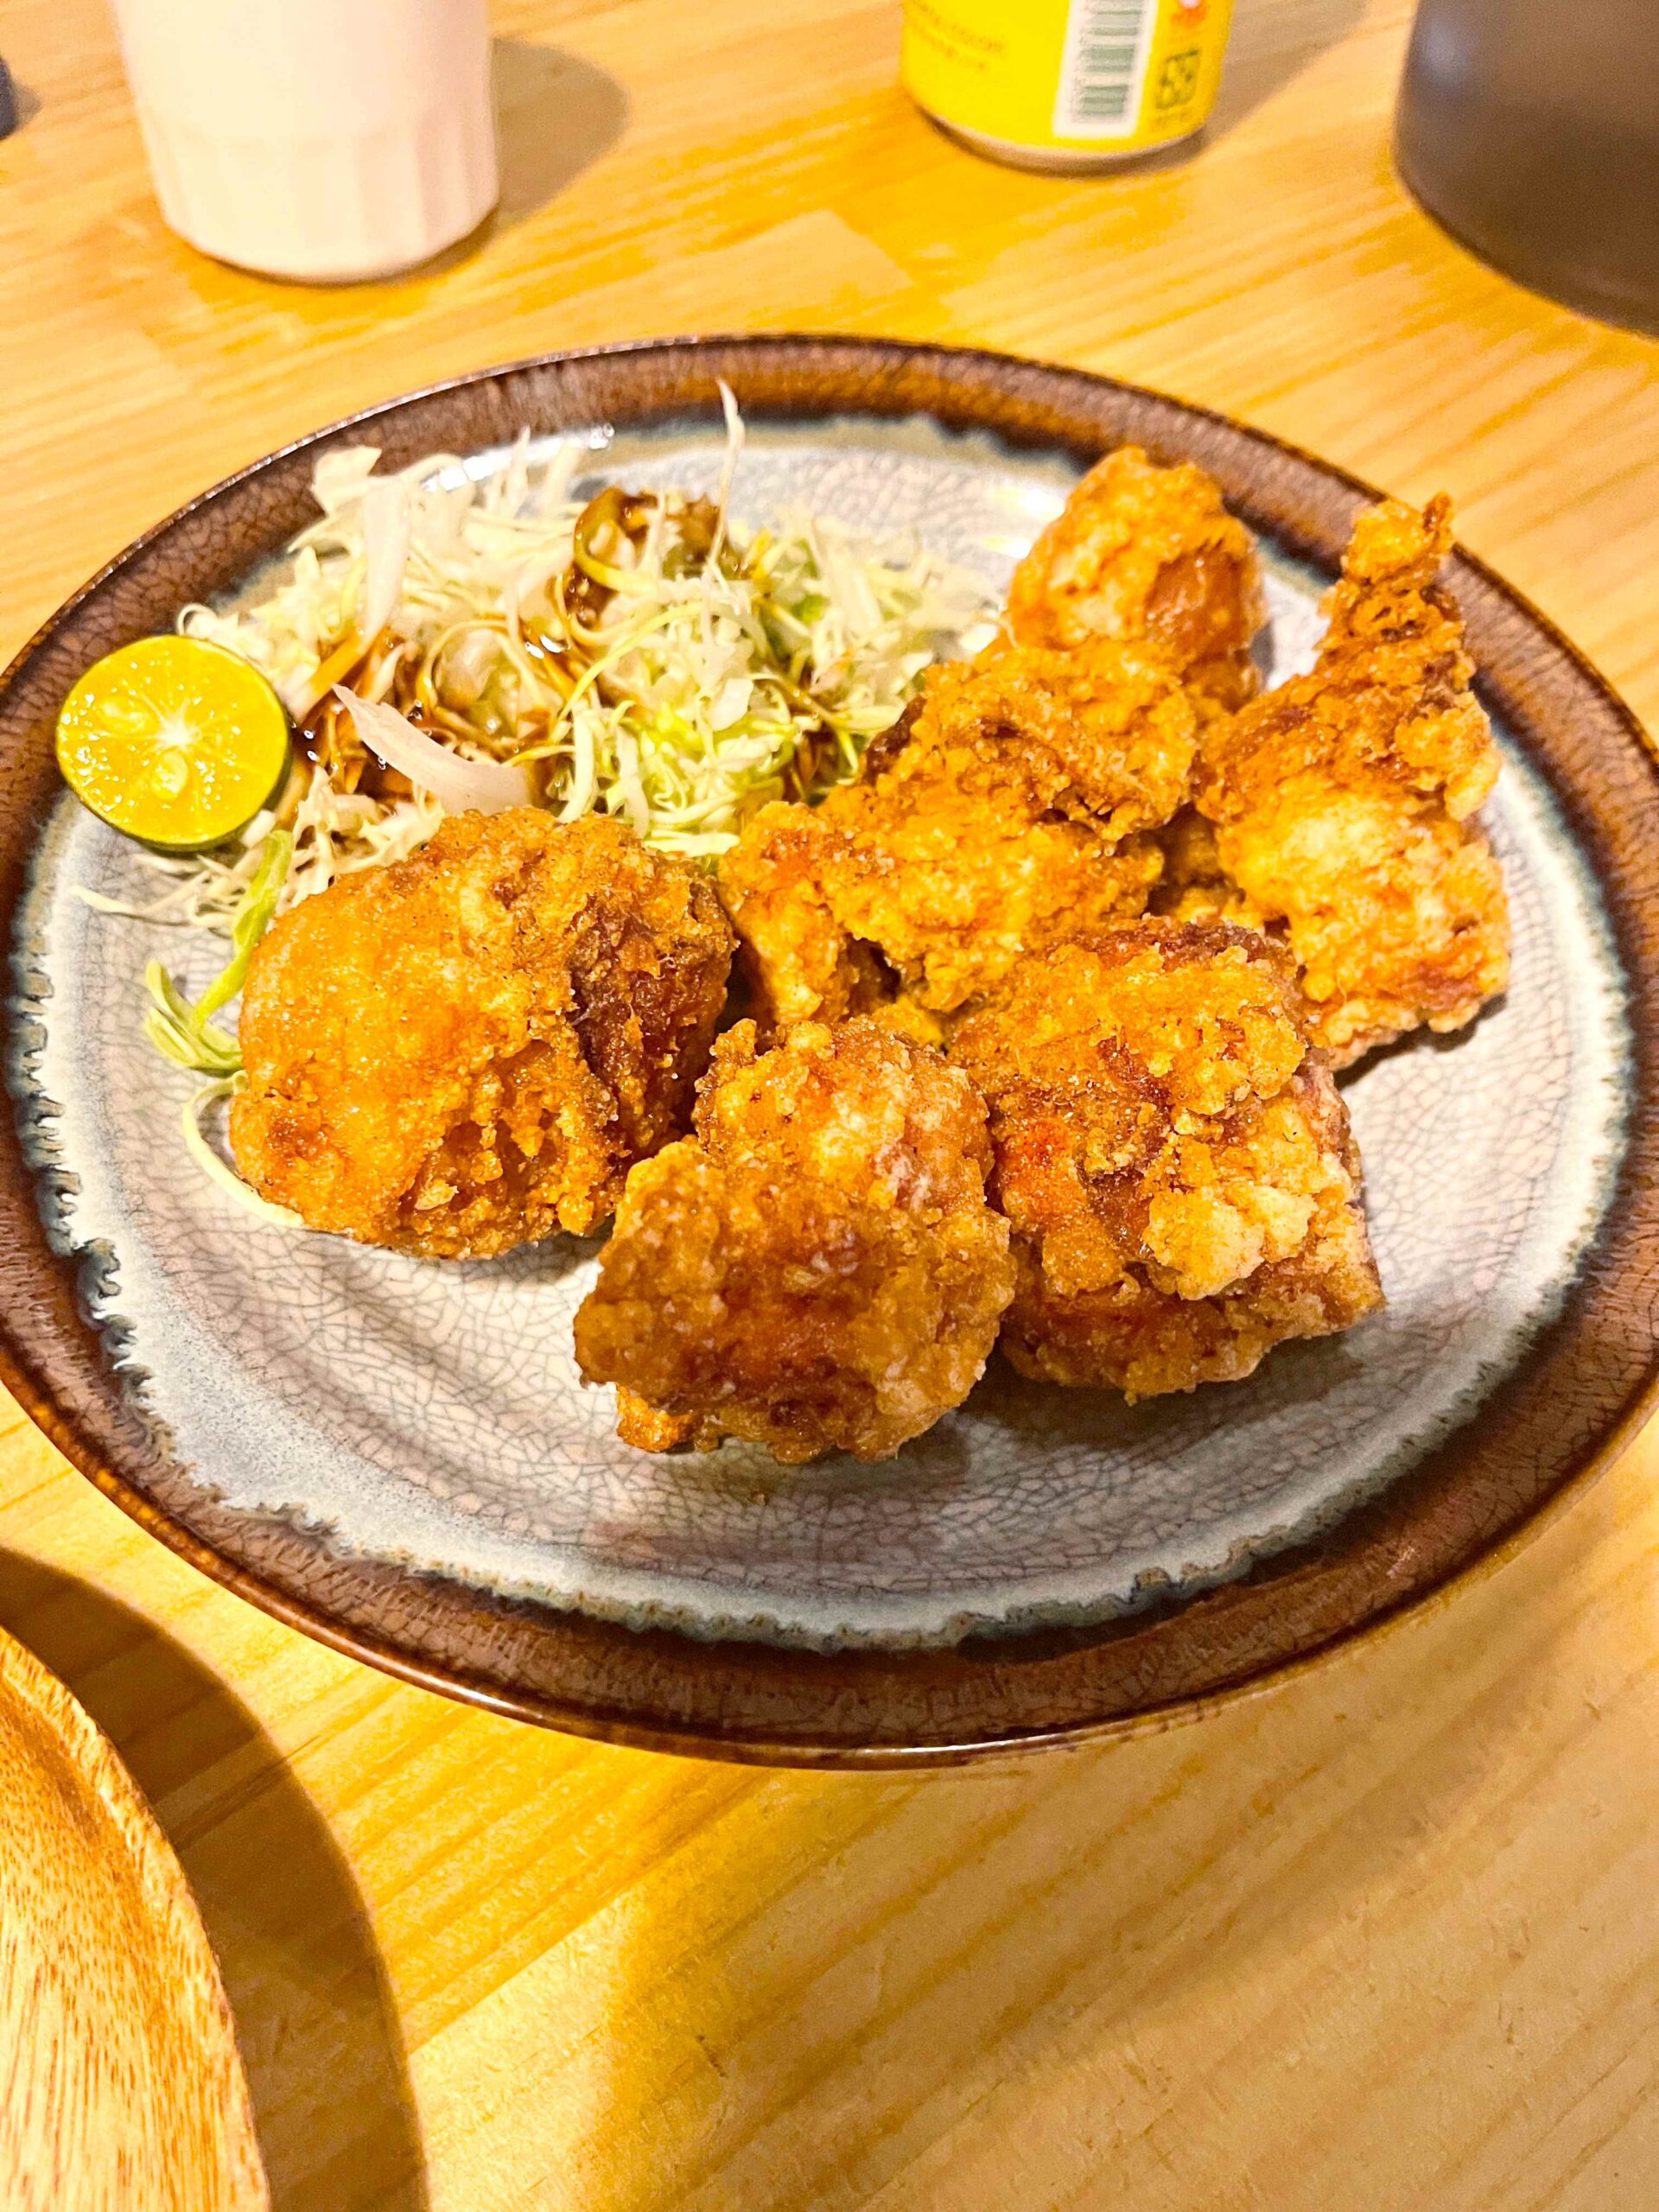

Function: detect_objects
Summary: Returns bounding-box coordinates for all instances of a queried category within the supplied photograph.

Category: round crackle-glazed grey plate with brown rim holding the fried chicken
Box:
[0,339,1659,1763]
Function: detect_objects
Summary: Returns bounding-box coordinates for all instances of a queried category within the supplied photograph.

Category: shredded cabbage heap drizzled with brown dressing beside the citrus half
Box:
[100,402,987,931]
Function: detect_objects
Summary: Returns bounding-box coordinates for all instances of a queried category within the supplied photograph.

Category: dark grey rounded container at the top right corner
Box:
[1395,0,1659,332]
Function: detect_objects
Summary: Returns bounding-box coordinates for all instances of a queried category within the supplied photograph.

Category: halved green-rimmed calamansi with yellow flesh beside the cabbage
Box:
[58,637,288,852]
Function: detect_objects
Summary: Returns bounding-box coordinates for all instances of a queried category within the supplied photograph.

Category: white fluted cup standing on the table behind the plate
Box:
[113,0,498,283]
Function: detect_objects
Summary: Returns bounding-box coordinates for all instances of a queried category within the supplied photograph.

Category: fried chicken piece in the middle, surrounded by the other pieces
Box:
[719,639,1197,1033]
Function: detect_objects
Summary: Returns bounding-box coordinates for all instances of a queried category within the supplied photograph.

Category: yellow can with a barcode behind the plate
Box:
[900,0,1232,168]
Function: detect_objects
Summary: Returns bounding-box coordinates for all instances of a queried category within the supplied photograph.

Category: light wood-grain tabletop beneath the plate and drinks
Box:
[0,0,1659,2212]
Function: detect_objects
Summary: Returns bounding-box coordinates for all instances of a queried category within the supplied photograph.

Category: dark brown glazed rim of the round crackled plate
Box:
[0,332,1659,1767]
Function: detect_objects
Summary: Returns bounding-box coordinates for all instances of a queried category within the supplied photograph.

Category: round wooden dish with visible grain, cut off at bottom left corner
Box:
[0,1630,270,2212]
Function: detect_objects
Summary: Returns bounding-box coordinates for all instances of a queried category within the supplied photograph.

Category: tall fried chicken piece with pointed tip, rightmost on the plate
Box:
[1170,498,1509,1066]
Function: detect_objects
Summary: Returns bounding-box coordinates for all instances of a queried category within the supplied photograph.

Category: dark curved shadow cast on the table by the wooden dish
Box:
[0,1553,429,2212]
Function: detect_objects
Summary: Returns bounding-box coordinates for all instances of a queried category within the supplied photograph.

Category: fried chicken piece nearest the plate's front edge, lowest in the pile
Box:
[575,1020,1013,1465]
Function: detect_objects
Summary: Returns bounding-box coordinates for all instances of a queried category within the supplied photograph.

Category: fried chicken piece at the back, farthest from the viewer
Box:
[1007,445,1268,712]
